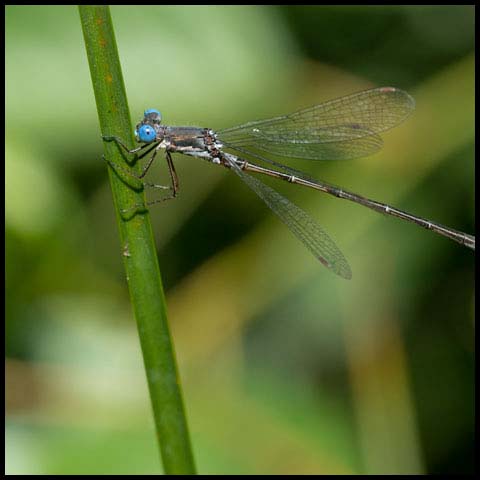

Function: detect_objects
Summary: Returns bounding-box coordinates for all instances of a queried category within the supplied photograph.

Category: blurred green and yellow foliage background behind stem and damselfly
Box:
[5,6,475,474]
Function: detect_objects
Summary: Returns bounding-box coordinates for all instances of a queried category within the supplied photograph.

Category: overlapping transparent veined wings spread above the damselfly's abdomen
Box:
[217,87,415,160]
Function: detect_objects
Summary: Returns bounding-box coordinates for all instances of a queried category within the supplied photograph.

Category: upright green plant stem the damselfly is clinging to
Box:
[79,6,195,474]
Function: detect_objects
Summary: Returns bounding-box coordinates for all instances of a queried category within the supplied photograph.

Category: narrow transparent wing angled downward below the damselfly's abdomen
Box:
[224,154,352,279]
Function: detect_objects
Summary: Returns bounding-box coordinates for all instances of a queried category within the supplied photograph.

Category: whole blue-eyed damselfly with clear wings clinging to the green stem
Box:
[104,87,475,279]
